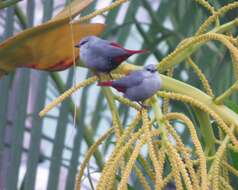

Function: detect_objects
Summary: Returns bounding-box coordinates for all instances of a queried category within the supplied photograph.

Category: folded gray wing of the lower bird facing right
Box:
[113,71,144,88]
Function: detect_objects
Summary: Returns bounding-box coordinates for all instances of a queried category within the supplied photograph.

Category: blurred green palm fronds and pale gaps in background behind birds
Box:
[0,0,238,190]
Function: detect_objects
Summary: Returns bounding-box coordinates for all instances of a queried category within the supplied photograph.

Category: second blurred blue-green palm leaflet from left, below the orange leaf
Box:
[6,70,29,190]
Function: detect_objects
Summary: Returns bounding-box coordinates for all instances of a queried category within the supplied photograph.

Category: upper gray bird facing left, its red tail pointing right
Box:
[75,36,147,78]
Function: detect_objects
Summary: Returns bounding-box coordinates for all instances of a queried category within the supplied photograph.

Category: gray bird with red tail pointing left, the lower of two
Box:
[98,64,162,107]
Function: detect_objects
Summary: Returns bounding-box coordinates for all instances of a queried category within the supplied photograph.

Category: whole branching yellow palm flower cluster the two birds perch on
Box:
[37,0,238,190]
